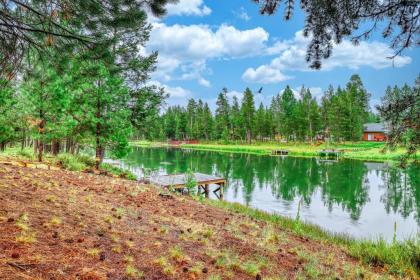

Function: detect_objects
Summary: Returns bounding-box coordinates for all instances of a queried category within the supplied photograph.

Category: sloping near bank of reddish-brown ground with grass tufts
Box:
[0,164,419,279]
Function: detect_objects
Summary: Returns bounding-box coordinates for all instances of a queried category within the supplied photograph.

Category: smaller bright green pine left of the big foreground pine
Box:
[19,54,74,162]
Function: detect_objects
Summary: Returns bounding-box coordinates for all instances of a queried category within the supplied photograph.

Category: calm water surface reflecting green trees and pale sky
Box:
[110,148,420,240]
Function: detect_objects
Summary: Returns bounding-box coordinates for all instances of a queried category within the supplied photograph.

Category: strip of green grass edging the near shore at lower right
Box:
[200,199,420,279]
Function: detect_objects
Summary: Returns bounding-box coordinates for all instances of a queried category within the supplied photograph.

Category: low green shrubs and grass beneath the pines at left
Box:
[0,148,136,180]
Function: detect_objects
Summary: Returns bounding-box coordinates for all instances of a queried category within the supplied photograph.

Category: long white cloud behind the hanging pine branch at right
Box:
[242,31,411,83]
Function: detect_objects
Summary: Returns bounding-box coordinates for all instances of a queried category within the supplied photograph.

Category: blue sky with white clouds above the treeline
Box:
[144,0,420,108]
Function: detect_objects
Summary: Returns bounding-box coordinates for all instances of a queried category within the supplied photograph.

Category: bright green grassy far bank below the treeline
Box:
[177,142,414,161]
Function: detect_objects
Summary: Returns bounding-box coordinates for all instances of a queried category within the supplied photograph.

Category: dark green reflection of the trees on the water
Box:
[126,148,420,224]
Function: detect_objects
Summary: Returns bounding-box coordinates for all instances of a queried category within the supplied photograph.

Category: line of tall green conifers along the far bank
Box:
[143,75,415,143]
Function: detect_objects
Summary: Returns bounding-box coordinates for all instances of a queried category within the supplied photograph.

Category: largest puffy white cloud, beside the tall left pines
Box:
[146,22,269,87]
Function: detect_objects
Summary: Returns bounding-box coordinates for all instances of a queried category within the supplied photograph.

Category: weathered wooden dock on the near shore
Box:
[150,173,226,199]
